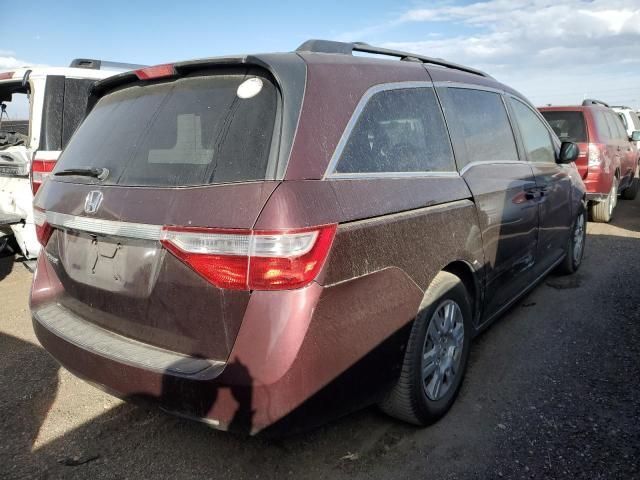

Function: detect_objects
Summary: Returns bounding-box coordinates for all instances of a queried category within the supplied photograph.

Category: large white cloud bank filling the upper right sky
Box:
[342,0,640,106]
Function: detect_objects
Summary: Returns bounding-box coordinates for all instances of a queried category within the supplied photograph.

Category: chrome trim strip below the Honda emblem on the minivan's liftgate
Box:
[46,212,162,240]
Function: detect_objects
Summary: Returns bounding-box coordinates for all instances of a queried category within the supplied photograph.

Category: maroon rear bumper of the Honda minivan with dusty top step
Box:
[31,255,422,434]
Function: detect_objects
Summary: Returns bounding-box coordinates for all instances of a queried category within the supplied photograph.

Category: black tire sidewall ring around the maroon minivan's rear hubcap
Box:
[411,280,473,424]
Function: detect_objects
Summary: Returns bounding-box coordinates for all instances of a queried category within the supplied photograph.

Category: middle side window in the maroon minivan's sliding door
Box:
[439,88,518,168]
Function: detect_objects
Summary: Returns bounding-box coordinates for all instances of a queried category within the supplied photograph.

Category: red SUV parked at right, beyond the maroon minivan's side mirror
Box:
[540,100,640,222]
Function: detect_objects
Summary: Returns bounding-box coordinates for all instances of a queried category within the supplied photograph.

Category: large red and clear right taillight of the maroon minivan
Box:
[161,225,336,290]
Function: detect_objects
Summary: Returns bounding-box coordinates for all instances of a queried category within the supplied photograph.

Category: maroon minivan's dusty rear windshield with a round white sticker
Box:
[55,72,277,187]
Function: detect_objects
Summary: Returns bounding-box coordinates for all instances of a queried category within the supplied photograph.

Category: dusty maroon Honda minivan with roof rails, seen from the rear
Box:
[31,40,585,434]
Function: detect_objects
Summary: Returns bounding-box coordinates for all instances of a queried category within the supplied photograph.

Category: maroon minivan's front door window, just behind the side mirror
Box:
[511,99,556,163]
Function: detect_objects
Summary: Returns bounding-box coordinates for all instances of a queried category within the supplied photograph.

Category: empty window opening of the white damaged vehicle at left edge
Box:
[0,82,29,149]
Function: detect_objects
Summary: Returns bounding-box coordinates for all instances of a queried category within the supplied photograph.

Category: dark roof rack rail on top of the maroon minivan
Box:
[296,40,491,78]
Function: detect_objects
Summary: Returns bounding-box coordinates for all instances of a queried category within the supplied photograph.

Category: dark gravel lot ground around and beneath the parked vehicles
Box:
[0,200,640,479]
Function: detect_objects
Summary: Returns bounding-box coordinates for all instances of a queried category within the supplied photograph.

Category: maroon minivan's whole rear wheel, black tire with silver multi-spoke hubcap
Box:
[380,272,472,426]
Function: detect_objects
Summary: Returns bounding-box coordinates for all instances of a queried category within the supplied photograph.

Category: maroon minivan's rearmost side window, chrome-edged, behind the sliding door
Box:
[336,88,455,173]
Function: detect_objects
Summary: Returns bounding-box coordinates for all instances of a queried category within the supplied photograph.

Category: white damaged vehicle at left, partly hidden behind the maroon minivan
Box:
[0,59,139,258]
